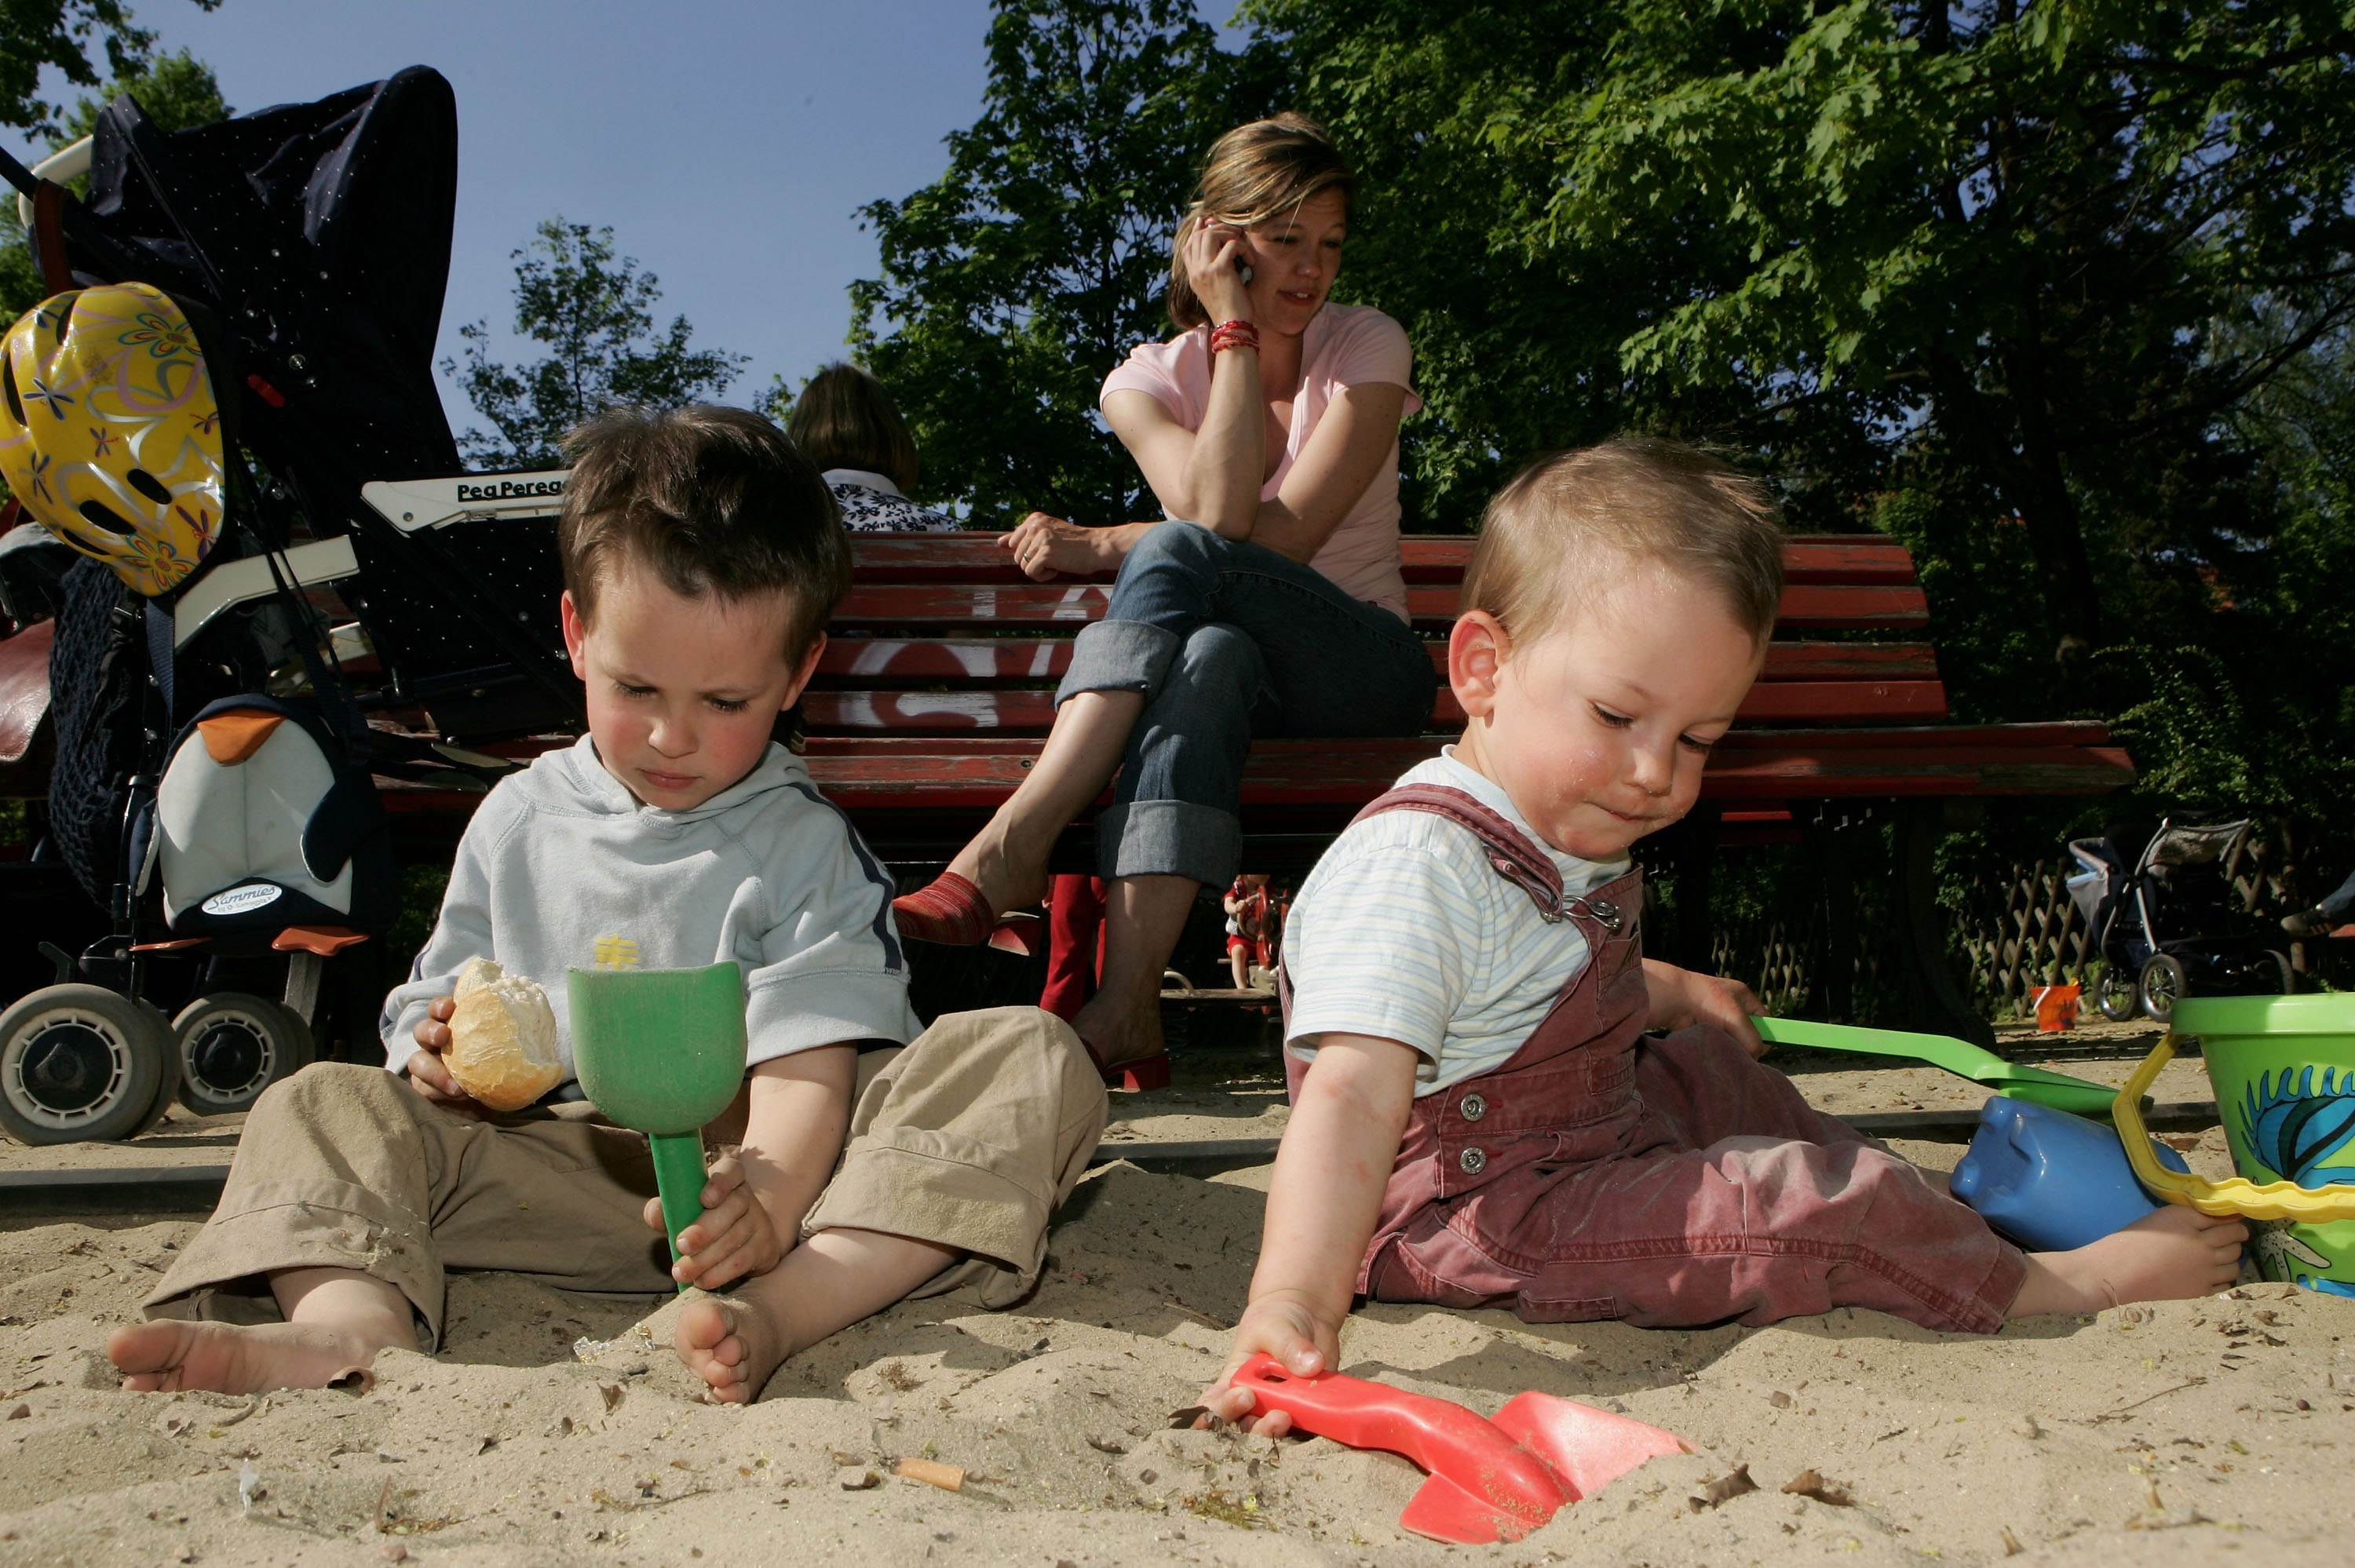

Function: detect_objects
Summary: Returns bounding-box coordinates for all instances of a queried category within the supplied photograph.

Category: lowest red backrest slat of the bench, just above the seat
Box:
[801,680,1945,735]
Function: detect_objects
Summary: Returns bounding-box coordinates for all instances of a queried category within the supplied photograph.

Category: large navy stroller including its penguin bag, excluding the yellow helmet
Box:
[0,68,582,1142]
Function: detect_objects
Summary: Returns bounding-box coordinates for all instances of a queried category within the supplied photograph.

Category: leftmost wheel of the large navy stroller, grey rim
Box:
[0,984,172,1144]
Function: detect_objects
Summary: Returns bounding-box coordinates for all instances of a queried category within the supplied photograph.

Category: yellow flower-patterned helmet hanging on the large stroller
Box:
[0,283,224,598]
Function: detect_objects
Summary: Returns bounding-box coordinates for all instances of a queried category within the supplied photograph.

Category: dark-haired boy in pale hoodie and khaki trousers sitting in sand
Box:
[106,407,1104,1401]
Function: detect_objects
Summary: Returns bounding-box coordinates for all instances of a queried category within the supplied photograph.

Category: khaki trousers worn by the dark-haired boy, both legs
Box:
[144,1008,1104,1351]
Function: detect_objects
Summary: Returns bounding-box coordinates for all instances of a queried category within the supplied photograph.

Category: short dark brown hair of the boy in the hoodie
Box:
[556,403,850,662]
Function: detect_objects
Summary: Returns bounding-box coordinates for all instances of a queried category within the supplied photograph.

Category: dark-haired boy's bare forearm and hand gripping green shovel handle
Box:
[645,1043,857,1290]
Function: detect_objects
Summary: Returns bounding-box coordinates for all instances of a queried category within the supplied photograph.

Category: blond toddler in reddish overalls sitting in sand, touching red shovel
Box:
[1203,440,2244,1431]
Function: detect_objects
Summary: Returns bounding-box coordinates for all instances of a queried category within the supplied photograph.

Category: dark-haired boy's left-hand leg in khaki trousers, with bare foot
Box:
[106,1062,669,1391]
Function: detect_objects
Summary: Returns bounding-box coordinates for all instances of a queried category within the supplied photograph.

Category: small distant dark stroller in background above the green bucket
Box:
[2068,822,2294,1024]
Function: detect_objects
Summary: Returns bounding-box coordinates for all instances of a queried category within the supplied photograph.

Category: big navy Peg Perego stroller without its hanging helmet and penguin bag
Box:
[0,66,598,1142]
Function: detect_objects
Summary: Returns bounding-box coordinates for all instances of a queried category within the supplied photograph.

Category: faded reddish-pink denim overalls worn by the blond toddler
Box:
[1286,784,2025,1333]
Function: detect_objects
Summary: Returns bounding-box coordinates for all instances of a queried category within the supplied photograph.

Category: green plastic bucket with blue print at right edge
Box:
[2174,996,2355,1295]
